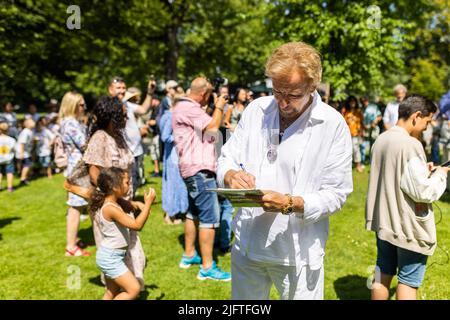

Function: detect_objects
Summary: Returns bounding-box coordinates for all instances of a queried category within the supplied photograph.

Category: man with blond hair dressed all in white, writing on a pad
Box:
[218,42,353,299]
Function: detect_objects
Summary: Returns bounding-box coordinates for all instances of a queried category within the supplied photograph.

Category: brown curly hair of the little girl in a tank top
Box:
[89,167,126,218]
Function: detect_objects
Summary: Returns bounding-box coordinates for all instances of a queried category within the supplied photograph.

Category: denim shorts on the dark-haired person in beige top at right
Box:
[377,237,428,288]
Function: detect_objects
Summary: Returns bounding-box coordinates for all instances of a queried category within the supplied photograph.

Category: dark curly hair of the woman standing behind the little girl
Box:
[89,96,127,149]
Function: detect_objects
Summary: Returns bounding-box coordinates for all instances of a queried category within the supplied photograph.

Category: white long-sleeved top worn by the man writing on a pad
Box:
[217,92,353,272]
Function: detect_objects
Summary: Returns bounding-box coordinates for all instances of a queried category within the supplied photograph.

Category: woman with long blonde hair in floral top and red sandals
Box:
[59,92,90,256]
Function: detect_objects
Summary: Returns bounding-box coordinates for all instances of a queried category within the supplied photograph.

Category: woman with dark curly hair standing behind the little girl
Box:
[83,97,145,288]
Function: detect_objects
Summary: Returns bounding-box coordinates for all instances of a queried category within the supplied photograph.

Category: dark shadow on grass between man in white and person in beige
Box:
[334,275,395,300]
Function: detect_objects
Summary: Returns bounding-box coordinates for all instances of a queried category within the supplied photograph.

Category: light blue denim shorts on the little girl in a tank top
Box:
[95,246,128,279]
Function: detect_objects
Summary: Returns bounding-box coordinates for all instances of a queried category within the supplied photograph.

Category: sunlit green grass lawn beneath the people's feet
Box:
[0,159,450,299]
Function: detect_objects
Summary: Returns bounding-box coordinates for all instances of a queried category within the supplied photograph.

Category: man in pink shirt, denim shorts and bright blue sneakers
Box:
[172,77,231,281]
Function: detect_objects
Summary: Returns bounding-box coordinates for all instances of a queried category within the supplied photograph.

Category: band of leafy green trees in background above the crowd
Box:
[0,0,450,104]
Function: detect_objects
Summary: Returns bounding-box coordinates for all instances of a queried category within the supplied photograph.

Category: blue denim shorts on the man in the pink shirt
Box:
[184,170,220,229]
